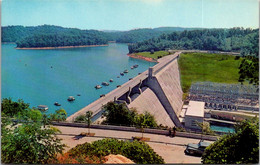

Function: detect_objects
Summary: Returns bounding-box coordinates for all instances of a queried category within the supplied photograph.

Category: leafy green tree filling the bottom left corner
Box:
[1,116,65,164]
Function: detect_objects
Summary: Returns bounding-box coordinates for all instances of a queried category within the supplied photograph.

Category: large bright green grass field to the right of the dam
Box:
[178,53,242,94]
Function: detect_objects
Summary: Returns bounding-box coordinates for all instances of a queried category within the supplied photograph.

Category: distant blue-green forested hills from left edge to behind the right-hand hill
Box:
[2,25,198,47]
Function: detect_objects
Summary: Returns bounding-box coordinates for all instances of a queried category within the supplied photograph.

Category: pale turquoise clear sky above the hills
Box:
[1,0,259,30]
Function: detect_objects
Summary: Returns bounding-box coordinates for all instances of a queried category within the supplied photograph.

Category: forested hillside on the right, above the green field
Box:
[128,28,259,53]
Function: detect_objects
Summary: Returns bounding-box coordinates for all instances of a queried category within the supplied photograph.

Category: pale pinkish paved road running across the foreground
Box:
[55,126,212,164]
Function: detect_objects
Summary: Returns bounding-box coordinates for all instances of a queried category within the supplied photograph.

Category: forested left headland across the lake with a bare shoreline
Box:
[2,25,108,48]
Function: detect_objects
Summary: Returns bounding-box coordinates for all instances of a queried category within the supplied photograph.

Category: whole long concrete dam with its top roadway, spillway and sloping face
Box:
[67,52,183,127]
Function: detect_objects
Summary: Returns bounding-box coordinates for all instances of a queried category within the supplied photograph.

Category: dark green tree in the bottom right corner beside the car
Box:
[202,118,259,164]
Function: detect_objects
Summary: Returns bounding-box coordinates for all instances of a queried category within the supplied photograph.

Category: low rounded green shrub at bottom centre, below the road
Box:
[68,139,164,164]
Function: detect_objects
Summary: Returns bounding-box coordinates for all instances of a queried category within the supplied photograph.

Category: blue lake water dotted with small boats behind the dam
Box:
[1,43,155,115]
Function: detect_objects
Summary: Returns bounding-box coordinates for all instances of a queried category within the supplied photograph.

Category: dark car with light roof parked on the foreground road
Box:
[184,140,210,156]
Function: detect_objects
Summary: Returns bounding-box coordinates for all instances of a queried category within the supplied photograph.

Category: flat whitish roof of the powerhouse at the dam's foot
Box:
[186,101,205,117]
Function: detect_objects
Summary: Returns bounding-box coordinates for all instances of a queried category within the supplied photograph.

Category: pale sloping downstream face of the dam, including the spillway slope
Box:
[134,54,183,127]
